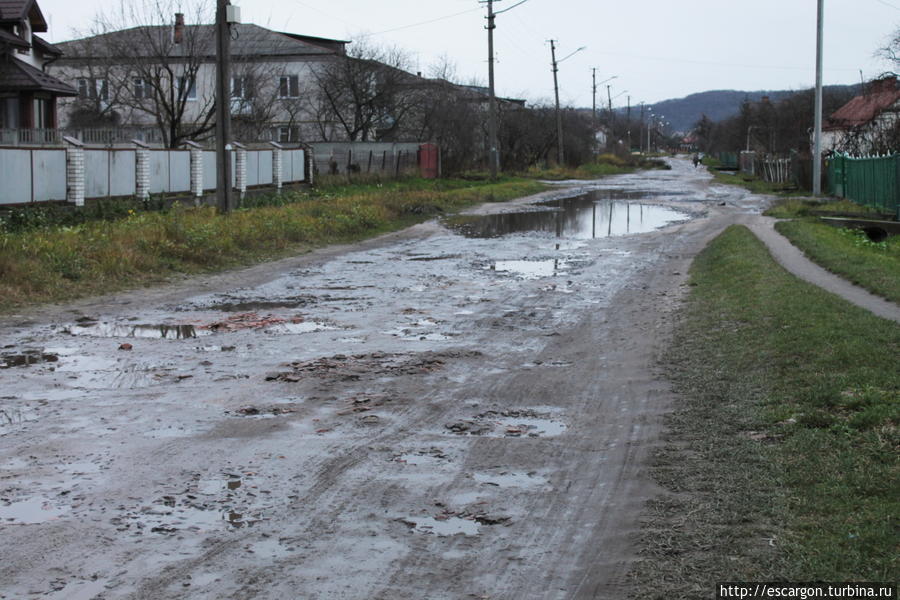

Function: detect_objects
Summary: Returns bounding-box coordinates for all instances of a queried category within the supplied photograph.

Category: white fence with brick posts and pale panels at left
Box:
[0,138,310,206]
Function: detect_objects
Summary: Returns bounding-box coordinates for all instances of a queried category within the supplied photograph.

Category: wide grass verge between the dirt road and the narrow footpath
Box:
[632,227,900,599]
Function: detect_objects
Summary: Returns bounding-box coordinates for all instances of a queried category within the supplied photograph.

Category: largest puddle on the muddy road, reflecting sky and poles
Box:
[446,190,688,239]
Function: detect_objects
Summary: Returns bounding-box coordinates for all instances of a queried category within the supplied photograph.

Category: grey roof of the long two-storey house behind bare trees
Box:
[54,23,346,61]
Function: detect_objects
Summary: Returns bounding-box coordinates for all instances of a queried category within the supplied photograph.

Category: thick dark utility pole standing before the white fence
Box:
[214,0,234,214]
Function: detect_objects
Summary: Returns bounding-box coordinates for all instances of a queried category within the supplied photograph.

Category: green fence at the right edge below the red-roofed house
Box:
[826,154,900,219]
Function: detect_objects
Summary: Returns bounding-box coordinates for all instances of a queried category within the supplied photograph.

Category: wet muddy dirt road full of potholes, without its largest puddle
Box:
[0,161,763,600]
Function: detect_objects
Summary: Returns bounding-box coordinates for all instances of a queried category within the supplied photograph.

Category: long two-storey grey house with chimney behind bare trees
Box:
[51,18,348,145]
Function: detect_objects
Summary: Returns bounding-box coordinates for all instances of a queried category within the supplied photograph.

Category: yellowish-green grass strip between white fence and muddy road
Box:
[0,179,546,311]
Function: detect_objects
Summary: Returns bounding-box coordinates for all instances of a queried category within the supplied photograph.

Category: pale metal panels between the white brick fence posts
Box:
[0,148,307,204]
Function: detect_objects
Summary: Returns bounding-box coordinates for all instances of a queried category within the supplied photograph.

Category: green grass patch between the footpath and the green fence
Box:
[775,219,900,303]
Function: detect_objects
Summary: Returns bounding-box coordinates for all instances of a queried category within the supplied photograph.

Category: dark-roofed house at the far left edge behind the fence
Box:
[0,0,78,130]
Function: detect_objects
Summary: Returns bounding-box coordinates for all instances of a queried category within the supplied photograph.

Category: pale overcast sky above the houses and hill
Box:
[39,0,900,107]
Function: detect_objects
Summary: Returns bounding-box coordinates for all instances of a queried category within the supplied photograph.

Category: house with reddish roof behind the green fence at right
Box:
[822,77,900,154]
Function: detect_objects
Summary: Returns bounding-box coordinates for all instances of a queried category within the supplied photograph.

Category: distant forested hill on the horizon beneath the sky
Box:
[612,84,859,132]
